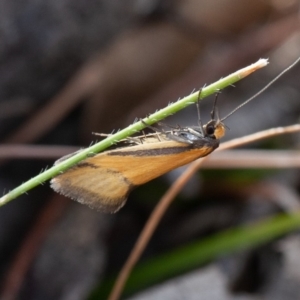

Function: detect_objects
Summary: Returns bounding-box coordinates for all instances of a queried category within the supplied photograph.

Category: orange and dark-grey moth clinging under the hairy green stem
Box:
[51,97,225,213]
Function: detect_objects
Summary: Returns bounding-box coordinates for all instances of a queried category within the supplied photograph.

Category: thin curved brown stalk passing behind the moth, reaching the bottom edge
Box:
[108,124,300,300]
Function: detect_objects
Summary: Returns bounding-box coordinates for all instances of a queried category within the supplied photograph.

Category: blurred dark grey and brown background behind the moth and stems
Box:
[0,0,300,300]
